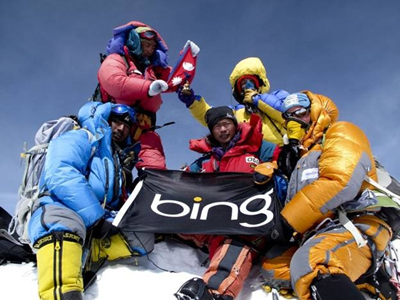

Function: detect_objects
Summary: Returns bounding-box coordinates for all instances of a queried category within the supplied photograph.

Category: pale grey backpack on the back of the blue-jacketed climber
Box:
[8,116,80,244]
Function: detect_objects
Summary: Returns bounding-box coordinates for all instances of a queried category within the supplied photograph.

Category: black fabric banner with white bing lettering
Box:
[113,170,281,239]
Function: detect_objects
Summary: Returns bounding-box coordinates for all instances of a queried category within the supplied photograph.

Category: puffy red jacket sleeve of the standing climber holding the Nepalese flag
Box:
[98,54,152,105]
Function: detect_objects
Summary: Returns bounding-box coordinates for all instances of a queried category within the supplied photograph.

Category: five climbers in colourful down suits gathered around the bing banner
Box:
[12,21,392,300]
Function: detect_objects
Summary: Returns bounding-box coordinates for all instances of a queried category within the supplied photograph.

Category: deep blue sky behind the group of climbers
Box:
[0,0,400,211]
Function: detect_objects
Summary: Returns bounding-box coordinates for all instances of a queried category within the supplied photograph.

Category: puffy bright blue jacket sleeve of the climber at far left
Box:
[44,130,104,227]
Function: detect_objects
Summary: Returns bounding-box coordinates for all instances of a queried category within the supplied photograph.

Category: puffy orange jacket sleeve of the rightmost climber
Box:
[281,122,375,233]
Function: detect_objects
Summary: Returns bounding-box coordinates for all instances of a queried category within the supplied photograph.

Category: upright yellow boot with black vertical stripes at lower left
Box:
[34,232,83,300]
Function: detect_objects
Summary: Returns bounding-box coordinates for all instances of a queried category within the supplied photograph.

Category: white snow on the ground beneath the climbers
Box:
[0,241,400,300]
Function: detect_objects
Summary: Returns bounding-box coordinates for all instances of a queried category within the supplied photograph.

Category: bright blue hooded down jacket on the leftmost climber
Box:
[29,102,121,241]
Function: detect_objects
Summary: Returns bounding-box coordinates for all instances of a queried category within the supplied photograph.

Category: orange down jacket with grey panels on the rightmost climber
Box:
[281,91,376,233]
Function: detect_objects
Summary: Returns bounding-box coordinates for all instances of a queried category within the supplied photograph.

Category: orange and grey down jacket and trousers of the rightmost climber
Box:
[262,91,391,299]
